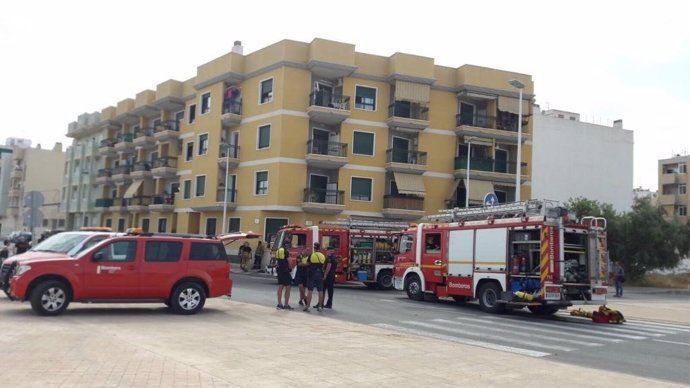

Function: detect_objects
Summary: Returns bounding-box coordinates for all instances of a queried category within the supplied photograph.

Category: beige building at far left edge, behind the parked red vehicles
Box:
[0,139,65,238]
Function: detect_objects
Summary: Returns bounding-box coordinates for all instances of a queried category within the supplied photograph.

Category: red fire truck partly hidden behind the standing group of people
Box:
[272,219,409,290]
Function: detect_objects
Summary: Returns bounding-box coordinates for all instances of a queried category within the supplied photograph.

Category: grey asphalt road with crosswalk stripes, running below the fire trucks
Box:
[232,273,690,384]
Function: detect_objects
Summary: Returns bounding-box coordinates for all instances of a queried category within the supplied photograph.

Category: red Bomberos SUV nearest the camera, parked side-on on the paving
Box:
[9,233,258,315]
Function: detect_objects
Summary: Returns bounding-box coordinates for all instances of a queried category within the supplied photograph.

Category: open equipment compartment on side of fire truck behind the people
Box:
[350,237,393,281]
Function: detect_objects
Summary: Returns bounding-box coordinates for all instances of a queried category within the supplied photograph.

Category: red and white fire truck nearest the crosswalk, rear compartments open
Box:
[394,200,608,315]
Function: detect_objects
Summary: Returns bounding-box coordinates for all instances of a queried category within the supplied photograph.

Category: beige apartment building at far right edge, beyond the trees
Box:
[658,155,690,224]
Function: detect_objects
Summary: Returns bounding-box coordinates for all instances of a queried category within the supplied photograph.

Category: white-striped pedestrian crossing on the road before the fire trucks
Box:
[373,311,690,357]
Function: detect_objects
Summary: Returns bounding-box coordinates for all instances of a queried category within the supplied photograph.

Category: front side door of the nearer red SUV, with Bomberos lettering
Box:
[84,240,141,299]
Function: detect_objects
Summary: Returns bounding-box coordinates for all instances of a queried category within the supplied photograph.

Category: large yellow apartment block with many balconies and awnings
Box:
[63,39,534,239]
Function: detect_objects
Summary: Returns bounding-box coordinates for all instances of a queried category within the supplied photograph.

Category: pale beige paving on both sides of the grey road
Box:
[0,280,690,388]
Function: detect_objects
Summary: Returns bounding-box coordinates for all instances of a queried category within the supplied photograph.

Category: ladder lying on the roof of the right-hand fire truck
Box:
[426,199,545,222]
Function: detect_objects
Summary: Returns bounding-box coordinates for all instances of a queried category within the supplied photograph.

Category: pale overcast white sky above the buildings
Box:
[0,0,690,190]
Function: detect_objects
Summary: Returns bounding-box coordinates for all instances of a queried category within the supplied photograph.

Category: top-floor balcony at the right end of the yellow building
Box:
[455,113,529,144]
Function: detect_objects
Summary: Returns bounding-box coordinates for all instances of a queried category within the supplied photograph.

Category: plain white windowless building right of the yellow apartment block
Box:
[531,106,634,212]
